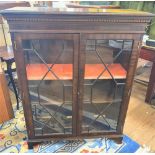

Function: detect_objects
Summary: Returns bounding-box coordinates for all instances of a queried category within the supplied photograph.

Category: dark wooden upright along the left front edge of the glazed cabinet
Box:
[11,34,34,139]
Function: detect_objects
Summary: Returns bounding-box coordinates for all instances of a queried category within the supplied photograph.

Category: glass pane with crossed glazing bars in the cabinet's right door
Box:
[82,39,133,133]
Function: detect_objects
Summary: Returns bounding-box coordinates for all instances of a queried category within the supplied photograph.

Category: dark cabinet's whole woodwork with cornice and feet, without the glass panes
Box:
[2,8,153,147]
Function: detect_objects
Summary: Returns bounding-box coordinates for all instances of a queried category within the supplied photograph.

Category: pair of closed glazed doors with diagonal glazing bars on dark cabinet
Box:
[15,33,135,137]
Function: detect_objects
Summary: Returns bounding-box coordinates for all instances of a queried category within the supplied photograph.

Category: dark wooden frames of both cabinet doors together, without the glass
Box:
[11,32,142,140]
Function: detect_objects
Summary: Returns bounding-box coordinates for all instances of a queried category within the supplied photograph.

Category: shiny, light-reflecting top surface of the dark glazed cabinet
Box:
[0,7,155,16]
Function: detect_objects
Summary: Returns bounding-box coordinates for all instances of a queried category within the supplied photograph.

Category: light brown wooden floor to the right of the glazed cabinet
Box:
[124,60,155,152]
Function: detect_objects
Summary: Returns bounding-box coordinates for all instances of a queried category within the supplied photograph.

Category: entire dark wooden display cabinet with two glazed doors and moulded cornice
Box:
[1,8,154,148]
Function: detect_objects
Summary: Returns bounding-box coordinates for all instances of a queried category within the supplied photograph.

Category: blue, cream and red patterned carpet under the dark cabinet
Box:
[0,102,149,153]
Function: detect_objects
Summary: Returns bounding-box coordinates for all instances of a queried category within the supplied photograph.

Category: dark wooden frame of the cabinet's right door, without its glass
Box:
[77,33,142,136]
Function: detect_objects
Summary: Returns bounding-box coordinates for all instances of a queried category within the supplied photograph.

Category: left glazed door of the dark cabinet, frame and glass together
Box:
[16,34,78,137]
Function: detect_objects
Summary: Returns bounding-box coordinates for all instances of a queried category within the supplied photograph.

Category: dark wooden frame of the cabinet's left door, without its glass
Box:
[11,32,79,139]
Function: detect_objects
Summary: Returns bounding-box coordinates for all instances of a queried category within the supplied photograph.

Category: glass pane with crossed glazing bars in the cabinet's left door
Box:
[23,39,73,135]
